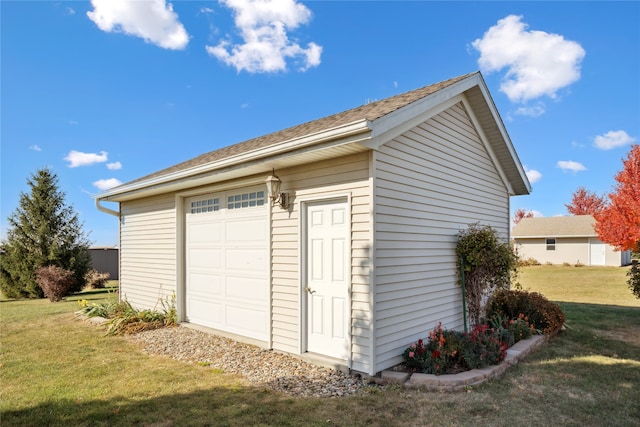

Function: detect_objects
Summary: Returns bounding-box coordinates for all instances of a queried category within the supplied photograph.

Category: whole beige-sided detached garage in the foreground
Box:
[96,73,530,374]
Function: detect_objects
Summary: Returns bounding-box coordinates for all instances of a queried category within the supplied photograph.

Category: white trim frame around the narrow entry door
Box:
[296,191,353,369]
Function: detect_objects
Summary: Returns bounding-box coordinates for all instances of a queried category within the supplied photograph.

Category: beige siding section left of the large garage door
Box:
[120,194,176,309]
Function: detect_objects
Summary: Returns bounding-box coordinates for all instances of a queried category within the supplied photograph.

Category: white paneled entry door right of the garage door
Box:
[305,201,350,360]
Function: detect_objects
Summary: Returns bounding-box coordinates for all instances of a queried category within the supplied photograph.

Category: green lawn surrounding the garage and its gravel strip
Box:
[0,266,640,427]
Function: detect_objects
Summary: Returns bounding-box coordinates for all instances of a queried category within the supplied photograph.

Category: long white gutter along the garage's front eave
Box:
[93,120,370,200]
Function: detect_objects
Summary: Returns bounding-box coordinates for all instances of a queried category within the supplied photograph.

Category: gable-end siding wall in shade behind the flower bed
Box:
[375,104,509,371]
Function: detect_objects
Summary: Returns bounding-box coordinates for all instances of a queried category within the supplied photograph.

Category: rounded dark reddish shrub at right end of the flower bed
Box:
[486,290,565,334]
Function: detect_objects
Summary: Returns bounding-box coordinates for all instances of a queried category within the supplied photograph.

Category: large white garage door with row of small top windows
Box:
[185,186,269,341]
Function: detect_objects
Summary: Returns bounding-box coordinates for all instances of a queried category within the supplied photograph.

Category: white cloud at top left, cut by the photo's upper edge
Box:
[87,0,189,49]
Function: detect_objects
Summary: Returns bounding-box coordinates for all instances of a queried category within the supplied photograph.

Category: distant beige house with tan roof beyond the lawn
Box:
[511,215,631,266]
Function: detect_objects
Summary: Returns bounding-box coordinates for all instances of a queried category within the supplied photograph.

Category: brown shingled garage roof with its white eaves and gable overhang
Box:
[95,72,531,201]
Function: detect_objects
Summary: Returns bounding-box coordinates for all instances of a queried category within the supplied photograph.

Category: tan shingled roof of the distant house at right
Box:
[511,215,597,239]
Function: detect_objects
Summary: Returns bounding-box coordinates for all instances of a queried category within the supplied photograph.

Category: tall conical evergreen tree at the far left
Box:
[0,168,91,298]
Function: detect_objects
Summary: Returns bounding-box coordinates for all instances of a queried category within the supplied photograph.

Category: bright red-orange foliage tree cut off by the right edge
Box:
[594,144,640,252]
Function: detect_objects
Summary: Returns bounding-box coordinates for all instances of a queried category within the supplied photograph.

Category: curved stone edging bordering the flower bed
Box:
[382,335,547,391]
